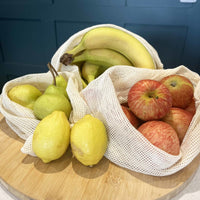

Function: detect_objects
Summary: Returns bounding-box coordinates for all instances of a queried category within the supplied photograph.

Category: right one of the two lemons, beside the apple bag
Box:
[70,115,108,166]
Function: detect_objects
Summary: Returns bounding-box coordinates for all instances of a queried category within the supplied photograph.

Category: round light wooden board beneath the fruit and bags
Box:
[0,114,200,200]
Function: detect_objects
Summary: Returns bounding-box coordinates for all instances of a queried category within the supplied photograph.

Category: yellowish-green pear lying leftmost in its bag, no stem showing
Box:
[8,84,42,109]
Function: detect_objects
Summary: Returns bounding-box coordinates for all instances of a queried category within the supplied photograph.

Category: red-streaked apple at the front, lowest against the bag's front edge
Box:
[138,121,180,155]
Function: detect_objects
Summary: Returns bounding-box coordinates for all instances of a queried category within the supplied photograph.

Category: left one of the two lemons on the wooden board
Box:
[32,111,70,163]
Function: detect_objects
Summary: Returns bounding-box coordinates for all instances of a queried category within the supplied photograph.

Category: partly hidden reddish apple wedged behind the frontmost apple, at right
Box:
[162,107,193,143]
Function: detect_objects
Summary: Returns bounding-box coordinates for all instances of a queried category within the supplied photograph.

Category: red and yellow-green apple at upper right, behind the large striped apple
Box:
[160,74,194,108]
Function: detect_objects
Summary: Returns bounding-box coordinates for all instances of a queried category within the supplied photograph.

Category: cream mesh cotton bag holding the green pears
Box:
[0,66,85,156]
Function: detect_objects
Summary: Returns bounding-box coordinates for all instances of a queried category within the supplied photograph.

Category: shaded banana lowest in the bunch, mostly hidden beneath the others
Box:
[82,62,107,83]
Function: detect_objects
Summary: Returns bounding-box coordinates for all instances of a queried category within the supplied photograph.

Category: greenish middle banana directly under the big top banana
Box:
[63,49,132,67]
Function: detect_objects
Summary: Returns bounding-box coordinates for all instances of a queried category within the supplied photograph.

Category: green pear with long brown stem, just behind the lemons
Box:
[33,63,72,120]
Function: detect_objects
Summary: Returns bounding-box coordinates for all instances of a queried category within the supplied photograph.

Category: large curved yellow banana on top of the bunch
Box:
[67,27,156,69]
